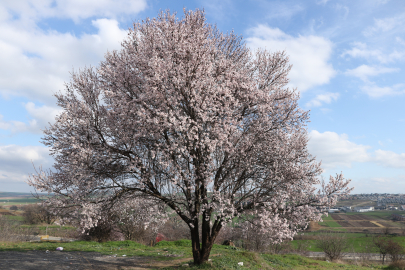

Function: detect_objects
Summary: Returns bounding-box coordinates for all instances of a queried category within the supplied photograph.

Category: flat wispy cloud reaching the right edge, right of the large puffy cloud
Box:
[341,42,405,63]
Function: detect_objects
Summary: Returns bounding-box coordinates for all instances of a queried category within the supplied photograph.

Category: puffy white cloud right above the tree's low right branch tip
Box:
[308,130,370,169]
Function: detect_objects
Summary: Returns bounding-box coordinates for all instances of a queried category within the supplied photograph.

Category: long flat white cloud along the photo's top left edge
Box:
[0,0,147,22]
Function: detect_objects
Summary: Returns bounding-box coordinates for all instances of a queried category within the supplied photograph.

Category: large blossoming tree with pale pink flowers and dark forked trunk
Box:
[29,10,350,264]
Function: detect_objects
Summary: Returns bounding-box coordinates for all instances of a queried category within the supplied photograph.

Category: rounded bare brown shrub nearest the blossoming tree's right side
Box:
[315,233,349,261]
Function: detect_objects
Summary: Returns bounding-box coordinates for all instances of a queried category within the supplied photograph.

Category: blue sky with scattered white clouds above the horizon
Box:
[0,0,405,193]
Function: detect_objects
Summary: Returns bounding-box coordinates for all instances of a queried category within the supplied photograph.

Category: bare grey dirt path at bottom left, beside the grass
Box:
[0,251,191,270]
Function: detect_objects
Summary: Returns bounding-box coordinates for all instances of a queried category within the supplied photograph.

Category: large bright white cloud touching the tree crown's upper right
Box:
[246,25,336,91]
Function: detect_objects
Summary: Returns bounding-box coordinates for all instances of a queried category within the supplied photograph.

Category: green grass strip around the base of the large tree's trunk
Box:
[0,240,389,270]
